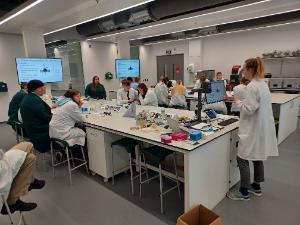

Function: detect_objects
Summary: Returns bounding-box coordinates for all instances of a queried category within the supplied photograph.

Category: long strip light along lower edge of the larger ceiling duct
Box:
[87,0,272,41]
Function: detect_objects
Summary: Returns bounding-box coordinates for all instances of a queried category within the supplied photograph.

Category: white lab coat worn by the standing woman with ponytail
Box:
[238,80,278,161]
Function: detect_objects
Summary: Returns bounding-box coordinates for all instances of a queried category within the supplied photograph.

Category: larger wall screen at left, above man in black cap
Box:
[16,58,63,83]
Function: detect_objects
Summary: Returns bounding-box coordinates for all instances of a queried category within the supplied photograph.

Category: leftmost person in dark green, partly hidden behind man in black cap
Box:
[8,83,27,132]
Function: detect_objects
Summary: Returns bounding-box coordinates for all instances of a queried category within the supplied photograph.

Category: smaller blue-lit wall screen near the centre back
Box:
[116,59,140,78]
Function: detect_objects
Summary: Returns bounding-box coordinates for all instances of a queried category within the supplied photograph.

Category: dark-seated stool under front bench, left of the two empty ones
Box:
[111,138,148,195]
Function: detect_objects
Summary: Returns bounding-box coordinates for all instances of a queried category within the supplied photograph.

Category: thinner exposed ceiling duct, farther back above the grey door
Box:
[130,10,300,46]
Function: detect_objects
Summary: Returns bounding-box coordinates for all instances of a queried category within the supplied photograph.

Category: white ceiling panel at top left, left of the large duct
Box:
[0,0,155,33]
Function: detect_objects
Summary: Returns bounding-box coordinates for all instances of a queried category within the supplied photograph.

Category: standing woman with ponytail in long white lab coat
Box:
[227,57,278,201]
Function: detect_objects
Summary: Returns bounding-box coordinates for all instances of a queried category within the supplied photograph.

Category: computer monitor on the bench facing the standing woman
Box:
[206,80,226,104]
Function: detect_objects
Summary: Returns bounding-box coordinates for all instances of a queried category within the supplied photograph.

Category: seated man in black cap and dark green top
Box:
[20,80,52,153]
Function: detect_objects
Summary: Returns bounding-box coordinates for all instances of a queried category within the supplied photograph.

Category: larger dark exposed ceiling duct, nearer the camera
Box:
[76,0,251,37]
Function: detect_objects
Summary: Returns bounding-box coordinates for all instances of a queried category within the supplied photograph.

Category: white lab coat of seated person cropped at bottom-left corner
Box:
[0,149,27,195]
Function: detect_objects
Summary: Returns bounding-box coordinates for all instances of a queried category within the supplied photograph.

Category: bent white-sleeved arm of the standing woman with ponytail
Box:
[236,87,260,115]
